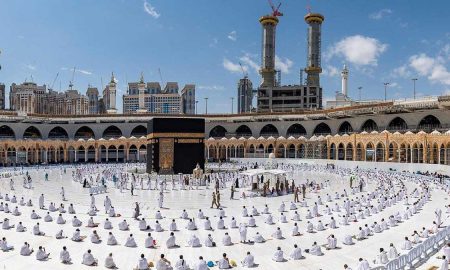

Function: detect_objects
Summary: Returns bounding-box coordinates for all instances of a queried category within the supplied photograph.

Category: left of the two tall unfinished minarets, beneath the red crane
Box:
[259,15,278,88]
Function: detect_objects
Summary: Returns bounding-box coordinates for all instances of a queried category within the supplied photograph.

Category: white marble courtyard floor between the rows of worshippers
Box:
[0,160,450,270]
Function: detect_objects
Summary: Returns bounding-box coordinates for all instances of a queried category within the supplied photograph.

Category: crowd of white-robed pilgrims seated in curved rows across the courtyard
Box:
[0,163,450,270]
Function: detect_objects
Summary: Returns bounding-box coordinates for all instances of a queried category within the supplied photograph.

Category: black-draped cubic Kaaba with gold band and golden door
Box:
[147,117,205,174]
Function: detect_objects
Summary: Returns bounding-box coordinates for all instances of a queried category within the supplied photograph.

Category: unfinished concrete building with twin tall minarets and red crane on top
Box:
[257,4,324,112]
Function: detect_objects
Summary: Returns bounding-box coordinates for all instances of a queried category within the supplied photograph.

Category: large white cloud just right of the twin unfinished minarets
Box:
[326,35,387,66]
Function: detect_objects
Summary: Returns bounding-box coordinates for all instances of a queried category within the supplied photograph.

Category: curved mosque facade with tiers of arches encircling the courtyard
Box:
[0,96,450,166]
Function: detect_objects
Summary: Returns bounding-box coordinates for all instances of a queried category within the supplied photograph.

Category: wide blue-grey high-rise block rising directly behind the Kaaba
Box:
[122,74,195,114]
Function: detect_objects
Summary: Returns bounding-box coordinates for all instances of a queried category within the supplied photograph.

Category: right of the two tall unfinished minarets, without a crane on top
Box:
[305,13,325,86]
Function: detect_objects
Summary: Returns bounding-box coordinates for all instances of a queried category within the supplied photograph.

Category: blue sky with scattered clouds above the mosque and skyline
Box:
[0,0,450,112]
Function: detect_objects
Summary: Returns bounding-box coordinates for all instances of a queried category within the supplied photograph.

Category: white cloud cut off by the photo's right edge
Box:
[409,53,450,85]
